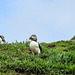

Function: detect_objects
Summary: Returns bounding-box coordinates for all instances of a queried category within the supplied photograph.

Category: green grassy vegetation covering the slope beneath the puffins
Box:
[0,40,75,75]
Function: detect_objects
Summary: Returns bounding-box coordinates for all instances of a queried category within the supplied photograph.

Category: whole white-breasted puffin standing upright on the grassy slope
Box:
[29,34,42,55]
